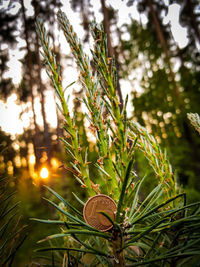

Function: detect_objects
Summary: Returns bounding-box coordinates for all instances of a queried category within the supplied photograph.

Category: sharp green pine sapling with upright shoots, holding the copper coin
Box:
[34,11,200,266]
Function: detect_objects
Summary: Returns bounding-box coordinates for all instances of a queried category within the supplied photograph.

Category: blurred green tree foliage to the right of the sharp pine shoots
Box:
[120,4,200,195]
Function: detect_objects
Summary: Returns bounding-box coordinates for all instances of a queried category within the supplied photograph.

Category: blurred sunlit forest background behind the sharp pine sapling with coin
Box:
[0,0,200,266]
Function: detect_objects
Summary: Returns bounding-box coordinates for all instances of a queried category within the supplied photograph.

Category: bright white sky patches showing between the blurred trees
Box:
[0,0,188,136]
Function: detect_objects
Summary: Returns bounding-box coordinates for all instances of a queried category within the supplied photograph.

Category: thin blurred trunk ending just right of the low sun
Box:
[33,0,52,166]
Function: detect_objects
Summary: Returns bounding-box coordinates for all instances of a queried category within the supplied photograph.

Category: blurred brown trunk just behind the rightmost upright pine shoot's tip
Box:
[101,0,123,111]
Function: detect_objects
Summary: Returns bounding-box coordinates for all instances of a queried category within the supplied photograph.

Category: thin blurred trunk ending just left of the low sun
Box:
[20,0,41,169]
